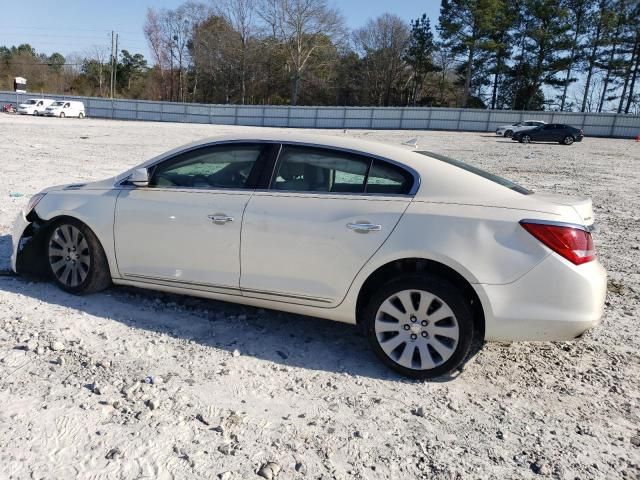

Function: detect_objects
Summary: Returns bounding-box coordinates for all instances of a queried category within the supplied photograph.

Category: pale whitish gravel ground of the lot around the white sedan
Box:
[0,115,640,479]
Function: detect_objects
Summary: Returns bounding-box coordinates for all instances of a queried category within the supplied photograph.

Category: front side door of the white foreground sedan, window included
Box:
[114,143,269,295]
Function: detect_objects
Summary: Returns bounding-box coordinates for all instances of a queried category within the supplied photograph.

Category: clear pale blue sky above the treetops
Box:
[0,0,440,60]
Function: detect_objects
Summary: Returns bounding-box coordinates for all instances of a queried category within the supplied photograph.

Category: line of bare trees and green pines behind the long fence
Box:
[0,0,640,113]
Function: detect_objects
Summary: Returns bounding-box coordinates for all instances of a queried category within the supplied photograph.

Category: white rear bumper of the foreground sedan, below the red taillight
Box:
[478,254,607,341]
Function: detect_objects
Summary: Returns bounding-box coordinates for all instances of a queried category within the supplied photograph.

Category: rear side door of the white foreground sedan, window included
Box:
[240,145,418,307]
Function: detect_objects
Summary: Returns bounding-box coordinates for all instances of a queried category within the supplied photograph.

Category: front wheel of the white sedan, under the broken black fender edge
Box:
[43,218,111,295]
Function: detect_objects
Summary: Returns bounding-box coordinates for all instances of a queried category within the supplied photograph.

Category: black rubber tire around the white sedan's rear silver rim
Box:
[361,274,474,380]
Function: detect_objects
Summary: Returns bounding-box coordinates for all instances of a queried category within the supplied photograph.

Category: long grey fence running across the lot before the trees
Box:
[0,92,640,138]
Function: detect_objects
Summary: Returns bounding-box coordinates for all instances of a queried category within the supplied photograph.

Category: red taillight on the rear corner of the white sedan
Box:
[520,221,596,265]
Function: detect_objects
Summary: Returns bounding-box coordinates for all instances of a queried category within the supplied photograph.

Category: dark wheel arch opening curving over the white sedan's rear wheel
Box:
[356,257,485,338]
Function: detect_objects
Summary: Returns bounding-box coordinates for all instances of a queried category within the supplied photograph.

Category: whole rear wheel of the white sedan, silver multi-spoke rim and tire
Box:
[362,275,473,379]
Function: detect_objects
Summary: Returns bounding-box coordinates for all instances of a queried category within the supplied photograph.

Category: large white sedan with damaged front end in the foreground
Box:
[12,133,606,378]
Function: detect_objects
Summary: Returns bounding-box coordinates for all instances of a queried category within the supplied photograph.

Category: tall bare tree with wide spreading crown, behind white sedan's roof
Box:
[259,0,345,105]
